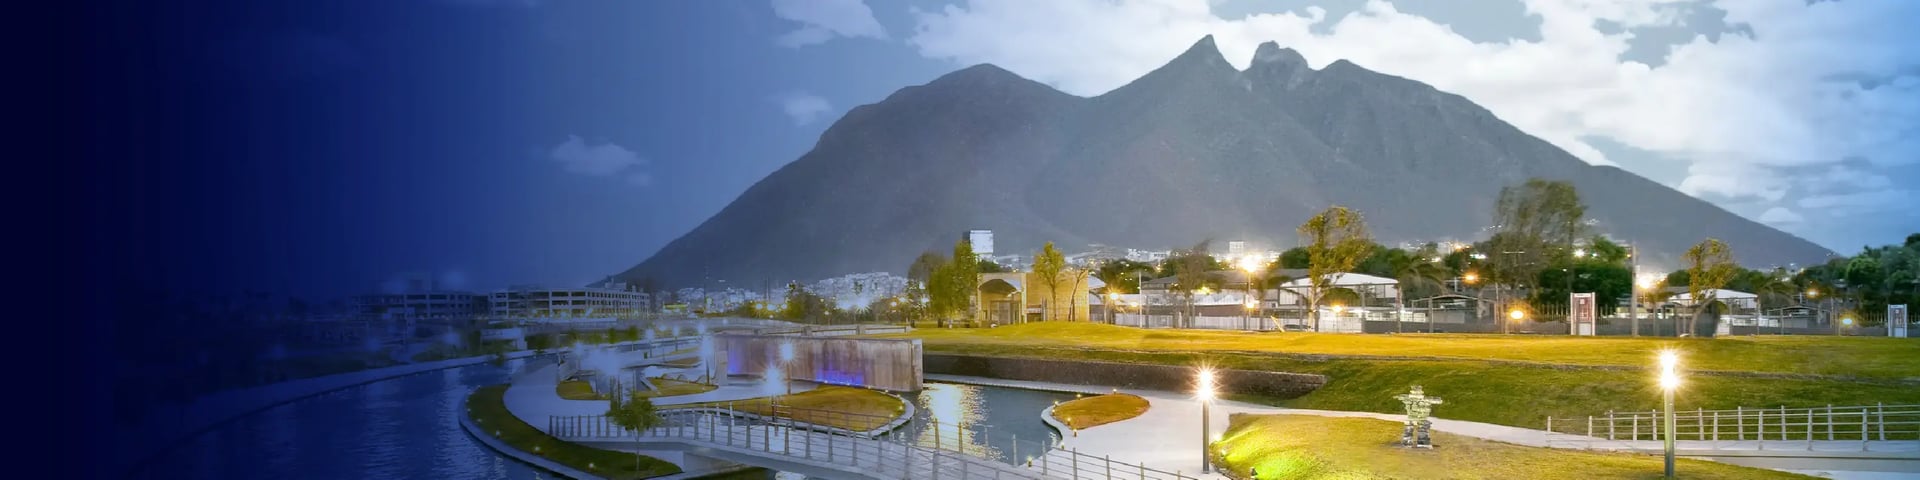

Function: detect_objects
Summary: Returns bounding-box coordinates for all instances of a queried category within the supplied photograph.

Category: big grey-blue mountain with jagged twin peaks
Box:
[620,36,1832,286]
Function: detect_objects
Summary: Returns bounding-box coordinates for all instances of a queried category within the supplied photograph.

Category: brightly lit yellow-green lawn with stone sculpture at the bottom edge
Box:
[1213,415,1812,480]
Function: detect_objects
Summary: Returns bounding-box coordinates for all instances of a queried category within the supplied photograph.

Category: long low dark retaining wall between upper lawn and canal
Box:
[922,353,1327,397]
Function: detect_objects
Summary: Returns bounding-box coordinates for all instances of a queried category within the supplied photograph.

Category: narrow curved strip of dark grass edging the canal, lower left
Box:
[467,384,680,480]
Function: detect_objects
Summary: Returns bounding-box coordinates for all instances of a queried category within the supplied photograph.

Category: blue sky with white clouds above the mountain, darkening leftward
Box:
[93,0,1920,298]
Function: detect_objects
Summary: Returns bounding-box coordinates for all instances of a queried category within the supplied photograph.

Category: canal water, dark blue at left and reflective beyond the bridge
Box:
[134,361,1073,480]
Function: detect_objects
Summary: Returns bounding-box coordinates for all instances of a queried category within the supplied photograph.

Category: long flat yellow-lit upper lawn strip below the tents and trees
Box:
[891,323,1920,380]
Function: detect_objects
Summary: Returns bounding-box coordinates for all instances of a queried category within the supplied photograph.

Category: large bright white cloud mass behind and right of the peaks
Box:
[908,0,1920,217]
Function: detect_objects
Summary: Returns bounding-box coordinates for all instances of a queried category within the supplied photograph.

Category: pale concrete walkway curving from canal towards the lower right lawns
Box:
[927,374,1920,478]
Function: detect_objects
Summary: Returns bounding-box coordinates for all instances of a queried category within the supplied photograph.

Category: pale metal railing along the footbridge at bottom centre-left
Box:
[547,407,1194,480]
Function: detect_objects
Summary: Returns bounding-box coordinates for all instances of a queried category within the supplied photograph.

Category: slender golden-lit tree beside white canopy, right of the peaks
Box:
[1298,205,1373,330]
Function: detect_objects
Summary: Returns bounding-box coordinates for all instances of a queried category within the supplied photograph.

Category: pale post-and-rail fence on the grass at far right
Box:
[1548,405,1920,451]
